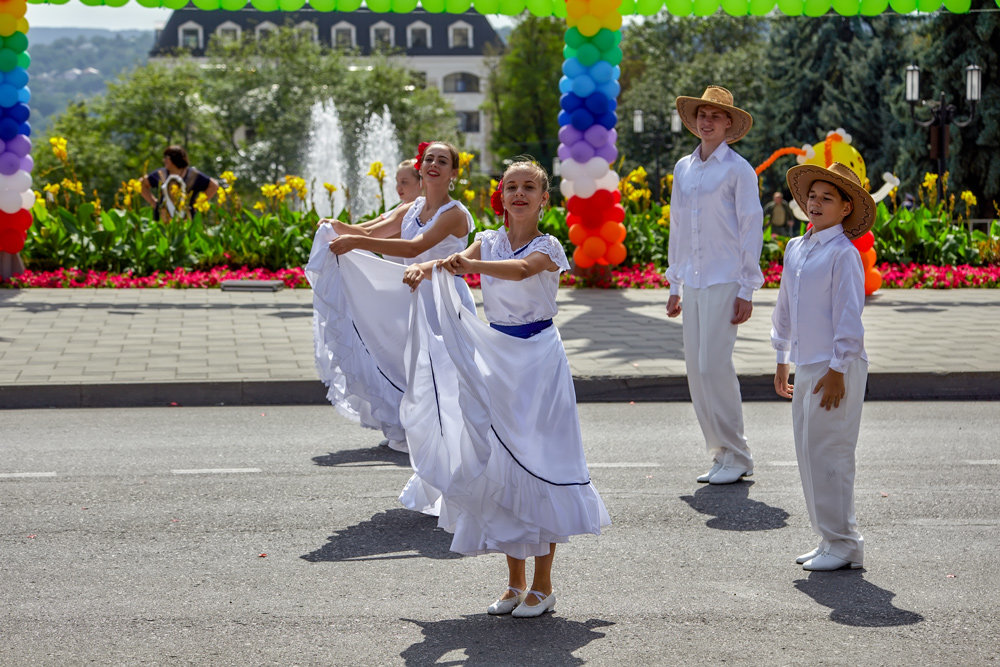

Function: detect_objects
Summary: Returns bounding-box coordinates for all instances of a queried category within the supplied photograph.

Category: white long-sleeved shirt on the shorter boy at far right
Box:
[771,225,868,373]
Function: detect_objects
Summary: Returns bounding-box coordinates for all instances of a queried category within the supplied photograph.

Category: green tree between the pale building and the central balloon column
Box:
[484,15,565,174]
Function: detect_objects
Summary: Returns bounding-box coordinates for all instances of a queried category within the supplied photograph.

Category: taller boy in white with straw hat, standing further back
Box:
[666,86,764,484]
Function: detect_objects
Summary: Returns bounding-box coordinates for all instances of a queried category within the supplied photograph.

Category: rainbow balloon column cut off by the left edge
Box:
[0,0,35,253]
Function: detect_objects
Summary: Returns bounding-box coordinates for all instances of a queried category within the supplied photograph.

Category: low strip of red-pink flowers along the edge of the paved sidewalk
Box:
[0,262,1000,289]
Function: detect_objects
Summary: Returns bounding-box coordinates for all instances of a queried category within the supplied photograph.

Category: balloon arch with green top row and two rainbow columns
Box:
[0,0,984,268]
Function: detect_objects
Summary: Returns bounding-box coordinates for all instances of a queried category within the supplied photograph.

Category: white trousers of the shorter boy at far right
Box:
[792,359,868,563]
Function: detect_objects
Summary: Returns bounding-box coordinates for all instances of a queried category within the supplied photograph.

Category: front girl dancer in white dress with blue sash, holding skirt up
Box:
[400,160,611,616]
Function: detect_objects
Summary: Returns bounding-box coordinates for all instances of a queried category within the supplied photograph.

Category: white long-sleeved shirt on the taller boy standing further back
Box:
[666,142,764,301]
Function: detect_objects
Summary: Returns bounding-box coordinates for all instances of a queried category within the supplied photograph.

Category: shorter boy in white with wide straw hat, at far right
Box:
[771,162,875,570]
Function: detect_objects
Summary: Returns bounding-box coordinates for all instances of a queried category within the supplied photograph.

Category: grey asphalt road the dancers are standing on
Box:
[0,402,1000,665]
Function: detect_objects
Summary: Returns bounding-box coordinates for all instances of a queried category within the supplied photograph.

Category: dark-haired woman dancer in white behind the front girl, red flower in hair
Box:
[306,142,475,451]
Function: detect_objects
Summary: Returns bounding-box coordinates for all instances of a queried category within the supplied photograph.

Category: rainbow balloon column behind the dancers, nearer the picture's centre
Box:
[559,0,626,269]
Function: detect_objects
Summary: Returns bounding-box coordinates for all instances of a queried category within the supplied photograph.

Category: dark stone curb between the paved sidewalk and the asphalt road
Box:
[0,372,1000,410]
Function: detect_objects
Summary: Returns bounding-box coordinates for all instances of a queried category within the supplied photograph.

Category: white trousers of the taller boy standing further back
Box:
[683,283,753,470]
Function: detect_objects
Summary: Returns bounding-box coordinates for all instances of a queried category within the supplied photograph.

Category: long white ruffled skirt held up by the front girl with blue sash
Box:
[400,271,611,558]
